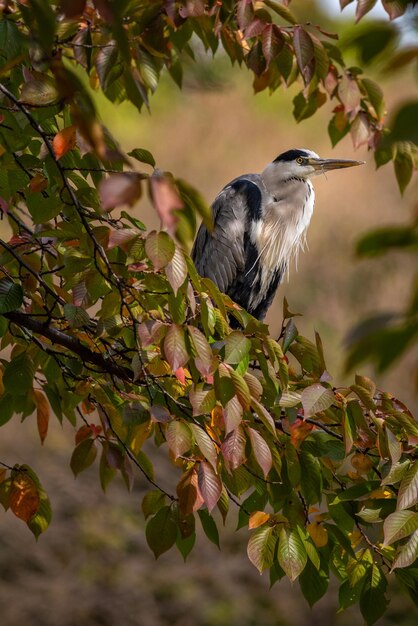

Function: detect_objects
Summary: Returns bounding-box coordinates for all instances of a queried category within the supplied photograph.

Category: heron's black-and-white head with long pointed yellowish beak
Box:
[268,150,364,180]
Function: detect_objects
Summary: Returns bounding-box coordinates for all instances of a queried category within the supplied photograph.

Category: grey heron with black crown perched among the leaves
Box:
[192,149,364,321]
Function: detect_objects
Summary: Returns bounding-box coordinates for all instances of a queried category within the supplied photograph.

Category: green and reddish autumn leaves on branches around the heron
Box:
[0,0,418,624]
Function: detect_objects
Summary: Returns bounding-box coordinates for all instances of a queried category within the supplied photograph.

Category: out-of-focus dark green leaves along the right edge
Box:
[342,8,418,376]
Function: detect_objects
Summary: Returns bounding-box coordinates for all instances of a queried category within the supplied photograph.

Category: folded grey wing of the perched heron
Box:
[192,174,262,293]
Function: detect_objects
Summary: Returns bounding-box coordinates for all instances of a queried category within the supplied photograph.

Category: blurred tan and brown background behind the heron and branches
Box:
[0,0,418,626]
